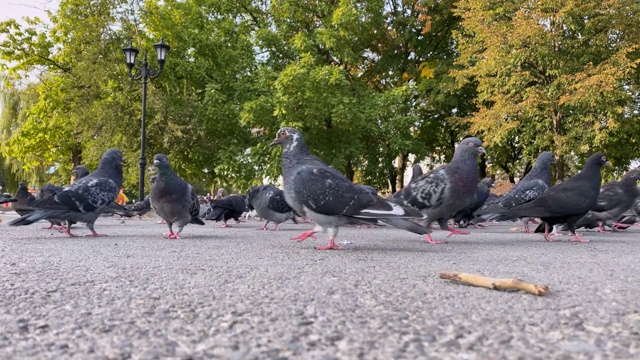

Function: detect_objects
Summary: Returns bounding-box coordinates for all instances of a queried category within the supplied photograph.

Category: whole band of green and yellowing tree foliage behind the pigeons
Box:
[0,0,640,197]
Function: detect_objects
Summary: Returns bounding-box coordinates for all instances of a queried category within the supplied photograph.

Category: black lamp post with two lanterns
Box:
[122,39,170,201]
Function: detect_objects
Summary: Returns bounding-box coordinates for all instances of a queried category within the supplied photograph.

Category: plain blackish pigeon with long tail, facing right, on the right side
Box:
[478,153,608,242]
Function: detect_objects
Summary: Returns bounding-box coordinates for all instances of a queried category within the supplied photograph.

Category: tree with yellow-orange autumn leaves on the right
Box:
[454,0,640,180]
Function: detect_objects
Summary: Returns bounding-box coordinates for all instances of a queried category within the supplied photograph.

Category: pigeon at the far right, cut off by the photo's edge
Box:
[576,169,640,232]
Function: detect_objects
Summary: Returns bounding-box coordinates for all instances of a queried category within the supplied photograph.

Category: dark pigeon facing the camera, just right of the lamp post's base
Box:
[149,154,204,239]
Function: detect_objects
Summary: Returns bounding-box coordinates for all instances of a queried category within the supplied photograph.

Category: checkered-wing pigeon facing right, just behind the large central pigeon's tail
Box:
[393,137,486,244]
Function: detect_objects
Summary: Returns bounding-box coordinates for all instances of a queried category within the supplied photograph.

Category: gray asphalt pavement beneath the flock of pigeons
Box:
[0,214,640,359]
